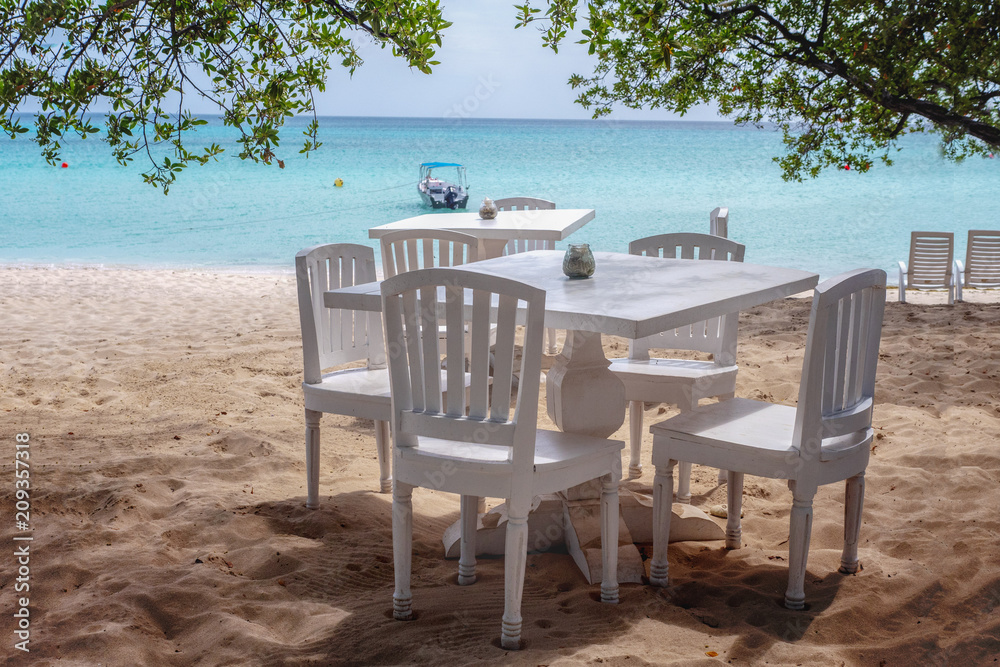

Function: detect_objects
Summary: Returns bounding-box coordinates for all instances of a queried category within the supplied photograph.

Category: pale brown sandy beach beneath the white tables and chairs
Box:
[0,268,1000,667]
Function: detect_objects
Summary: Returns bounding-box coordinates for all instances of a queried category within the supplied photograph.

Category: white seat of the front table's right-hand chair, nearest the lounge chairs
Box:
[649,398,871,477]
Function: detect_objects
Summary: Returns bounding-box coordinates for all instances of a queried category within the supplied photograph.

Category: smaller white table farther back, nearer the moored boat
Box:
[368,208,594,259]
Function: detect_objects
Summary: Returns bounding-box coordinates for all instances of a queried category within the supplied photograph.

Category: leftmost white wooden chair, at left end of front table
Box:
[295,243,392,509]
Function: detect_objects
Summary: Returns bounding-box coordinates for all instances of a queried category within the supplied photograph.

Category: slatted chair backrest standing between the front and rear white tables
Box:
[381,229,479,278]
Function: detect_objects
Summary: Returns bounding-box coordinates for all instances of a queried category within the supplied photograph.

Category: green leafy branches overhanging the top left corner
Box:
[0,0,450,192]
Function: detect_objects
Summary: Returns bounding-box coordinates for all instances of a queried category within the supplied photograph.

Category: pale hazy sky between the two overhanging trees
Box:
[318,0,720,120]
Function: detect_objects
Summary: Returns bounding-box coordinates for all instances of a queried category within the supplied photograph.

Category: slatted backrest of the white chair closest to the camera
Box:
[382,268,545,475]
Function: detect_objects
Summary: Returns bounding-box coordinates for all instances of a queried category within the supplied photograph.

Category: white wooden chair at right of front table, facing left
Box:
[649,269,885,609]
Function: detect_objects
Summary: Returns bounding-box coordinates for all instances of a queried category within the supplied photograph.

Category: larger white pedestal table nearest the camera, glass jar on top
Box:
[324,250,819,583]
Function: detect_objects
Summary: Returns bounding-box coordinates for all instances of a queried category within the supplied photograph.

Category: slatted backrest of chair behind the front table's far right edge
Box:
[628,232,746,366]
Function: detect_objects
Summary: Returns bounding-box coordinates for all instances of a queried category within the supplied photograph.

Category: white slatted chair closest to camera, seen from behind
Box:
[382,269,624,649]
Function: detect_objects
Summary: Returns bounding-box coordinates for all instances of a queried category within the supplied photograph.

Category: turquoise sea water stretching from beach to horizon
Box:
[0,118,1000,281]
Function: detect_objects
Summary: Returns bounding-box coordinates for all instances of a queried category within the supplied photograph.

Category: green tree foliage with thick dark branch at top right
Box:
[518,0,1000,180]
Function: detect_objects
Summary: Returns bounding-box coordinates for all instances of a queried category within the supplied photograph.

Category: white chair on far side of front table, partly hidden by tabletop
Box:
[610,233,746,503]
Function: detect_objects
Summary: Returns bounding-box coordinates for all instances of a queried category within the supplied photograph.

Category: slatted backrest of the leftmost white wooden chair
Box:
[295,243,384,384]
